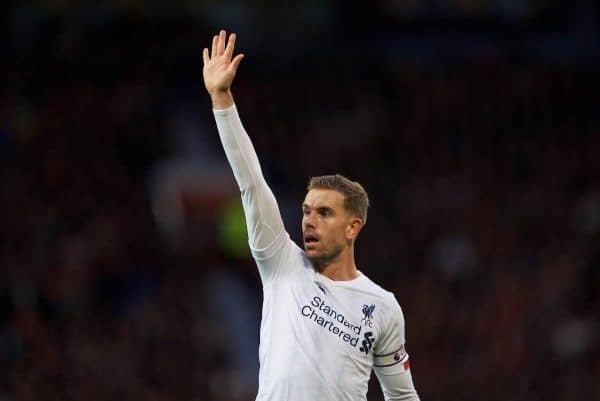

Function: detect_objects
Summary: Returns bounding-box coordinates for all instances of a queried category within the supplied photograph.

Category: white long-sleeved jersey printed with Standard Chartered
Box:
[214,106,418,401]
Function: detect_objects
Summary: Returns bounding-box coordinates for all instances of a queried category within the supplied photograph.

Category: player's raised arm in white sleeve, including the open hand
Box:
[202,31,289,282]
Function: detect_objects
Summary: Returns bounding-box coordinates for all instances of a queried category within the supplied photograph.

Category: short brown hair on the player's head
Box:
[306,174,369,224]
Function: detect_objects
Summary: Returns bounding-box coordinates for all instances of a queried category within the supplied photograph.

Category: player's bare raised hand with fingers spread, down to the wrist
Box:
[202,30,244,108]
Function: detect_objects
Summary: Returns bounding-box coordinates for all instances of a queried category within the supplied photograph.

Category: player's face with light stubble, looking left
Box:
[302,189,360,270]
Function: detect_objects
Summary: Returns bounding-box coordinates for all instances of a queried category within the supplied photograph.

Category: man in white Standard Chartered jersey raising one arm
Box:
[203,31,419,401]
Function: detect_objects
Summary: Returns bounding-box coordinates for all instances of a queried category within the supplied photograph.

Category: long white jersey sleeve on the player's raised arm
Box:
[213,105,291,284]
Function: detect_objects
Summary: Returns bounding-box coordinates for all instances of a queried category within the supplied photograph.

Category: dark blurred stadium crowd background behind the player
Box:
[0,0,600,401]
